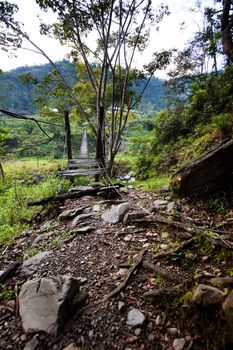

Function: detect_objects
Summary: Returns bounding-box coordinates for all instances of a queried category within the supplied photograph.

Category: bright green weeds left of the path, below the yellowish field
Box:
[0,161,70,245]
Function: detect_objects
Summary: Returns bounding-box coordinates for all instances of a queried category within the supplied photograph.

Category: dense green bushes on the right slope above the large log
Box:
[131,66,233,179]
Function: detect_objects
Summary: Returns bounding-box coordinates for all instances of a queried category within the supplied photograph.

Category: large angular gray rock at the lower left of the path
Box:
[19,276,79,336]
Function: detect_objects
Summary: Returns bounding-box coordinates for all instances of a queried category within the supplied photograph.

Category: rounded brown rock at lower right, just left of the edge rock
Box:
[192,284,224,308]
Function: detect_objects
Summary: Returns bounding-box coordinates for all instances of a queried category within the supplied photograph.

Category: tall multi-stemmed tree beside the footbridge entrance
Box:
[36,0,168,168]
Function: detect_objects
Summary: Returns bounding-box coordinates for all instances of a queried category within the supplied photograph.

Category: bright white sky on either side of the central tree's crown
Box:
[0,0,212,77]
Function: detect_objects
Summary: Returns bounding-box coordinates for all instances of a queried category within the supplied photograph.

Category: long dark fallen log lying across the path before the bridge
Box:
[28,185,119,207]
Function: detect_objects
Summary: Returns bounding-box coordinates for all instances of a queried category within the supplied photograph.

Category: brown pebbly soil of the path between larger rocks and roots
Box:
[0,188,233,350]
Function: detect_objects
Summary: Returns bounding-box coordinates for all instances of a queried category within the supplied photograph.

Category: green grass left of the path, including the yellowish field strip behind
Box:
[0,159,71,245]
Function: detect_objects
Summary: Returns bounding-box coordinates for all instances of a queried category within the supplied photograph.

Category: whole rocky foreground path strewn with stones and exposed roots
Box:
[0,183,233,350]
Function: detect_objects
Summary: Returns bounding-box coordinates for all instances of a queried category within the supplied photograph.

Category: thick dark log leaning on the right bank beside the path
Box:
[171,140,233,196]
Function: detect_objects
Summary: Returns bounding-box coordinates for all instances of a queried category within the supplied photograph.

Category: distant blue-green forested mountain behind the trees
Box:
[0,60,164,114]
